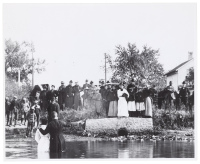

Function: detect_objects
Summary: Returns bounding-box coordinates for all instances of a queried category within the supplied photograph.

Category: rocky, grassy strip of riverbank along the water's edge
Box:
[5,125,195,142]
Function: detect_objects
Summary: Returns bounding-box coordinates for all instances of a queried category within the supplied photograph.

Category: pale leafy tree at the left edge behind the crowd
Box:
[5,39,45,81]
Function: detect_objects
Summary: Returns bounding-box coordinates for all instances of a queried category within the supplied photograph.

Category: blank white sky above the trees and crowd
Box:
[3,3,197,88]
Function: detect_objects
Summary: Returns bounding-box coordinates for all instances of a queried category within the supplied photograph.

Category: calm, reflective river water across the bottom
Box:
[5,140,195,159]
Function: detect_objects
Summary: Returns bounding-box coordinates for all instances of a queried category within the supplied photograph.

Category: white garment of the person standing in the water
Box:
[35,125,50,159]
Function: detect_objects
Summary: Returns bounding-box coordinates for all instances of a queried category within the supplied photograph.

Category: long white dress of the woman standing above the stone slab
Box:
[117,89,129,117]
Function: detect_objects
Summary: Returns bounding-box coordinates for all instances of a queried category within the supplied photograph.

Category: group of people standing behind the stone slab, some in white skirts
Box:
[100,79,156,117]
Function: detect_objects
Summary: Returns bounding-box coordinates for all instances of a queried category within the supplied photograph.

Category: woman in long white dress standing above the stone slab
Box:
[117,83,129,117]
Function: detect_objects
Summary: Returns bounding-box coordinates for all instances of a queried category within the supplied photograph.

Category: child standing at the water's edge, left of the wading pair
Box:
[26,108,36,138]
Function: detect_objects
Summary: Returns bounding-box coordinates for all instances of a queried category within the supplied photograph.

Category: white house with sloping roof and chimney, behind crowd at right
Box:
[165,53,194,90]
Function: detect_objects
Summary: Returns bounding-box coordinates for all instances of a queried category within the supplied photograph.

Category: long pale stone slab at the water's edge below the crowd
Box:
[85,117,153,134]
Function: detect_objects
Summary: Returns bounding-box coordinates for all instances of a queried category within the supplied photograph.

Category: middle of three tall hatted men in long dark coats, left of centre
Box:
[65,80,74,108]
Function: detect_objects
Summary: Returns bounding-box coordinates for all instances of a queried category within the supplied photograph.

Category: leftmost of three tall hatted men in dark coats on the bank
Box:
[58,81,66,110]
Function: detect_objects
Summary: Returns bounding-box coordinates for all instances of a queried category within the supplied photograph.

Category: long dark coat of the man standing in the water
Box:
[40,119,66,153]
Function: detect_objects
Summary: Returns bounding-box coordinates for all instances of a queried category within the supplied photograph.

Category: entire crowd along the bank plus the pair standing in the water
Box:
[5,79,194,158]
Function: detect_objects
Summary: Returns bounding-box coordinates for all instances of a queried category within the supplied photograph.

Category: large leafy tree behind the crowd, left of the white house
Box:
[108,43,166,88]
